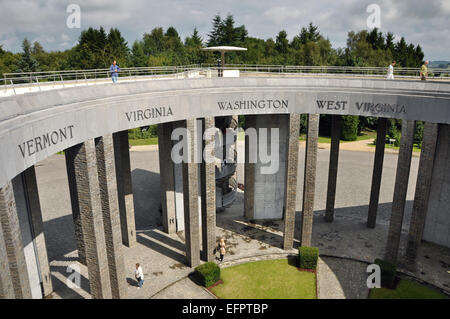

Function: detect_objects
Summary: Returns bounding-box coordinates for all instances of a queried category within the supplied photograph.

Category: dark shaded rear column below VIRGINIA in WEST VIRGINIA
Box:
[367,117,387,228]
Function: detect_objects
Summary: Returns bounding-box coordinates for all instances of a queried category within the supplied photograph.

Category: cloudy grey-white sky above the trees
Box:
[0,0,450,60]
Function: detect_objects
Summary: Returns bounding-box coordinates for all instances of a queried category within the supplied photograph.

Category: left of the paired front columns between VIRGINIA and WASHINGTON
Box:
[183,119,200,267]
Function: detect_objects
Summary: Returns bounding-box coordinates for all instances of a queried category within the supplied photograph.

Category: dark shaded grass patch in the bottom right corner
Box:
[369,278,448,299]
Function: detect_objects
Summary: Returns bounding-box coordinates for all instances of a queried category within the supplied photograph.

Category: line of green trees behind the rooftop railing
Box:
[0,14,424,77]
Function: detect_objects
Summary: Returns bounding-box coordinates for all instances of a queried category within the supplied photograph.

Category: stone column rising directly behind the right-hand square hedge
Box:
[301,114,319,246]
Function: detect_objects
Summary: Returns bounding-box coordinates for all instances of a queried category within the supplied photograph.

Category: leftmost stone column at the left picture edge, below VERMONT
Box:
[0,183,31,299]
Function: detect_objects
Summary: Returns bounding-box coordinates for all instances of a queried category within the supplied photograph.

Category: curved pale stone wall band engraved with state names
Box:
[0,77,450,187]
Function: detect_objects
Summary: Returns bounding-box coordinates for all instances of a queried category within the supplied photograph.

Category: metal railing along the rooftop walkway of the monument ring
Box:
[0,64,450,94]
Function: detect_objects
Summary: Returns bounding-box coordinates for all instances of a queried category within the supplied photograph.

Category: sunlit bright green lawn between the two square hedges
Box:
[211,259,316,299]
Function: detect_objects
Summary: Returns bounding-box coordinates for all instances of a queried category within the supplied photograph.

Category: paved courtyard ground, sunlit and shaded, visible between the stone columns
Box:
[36,144,450,299]
